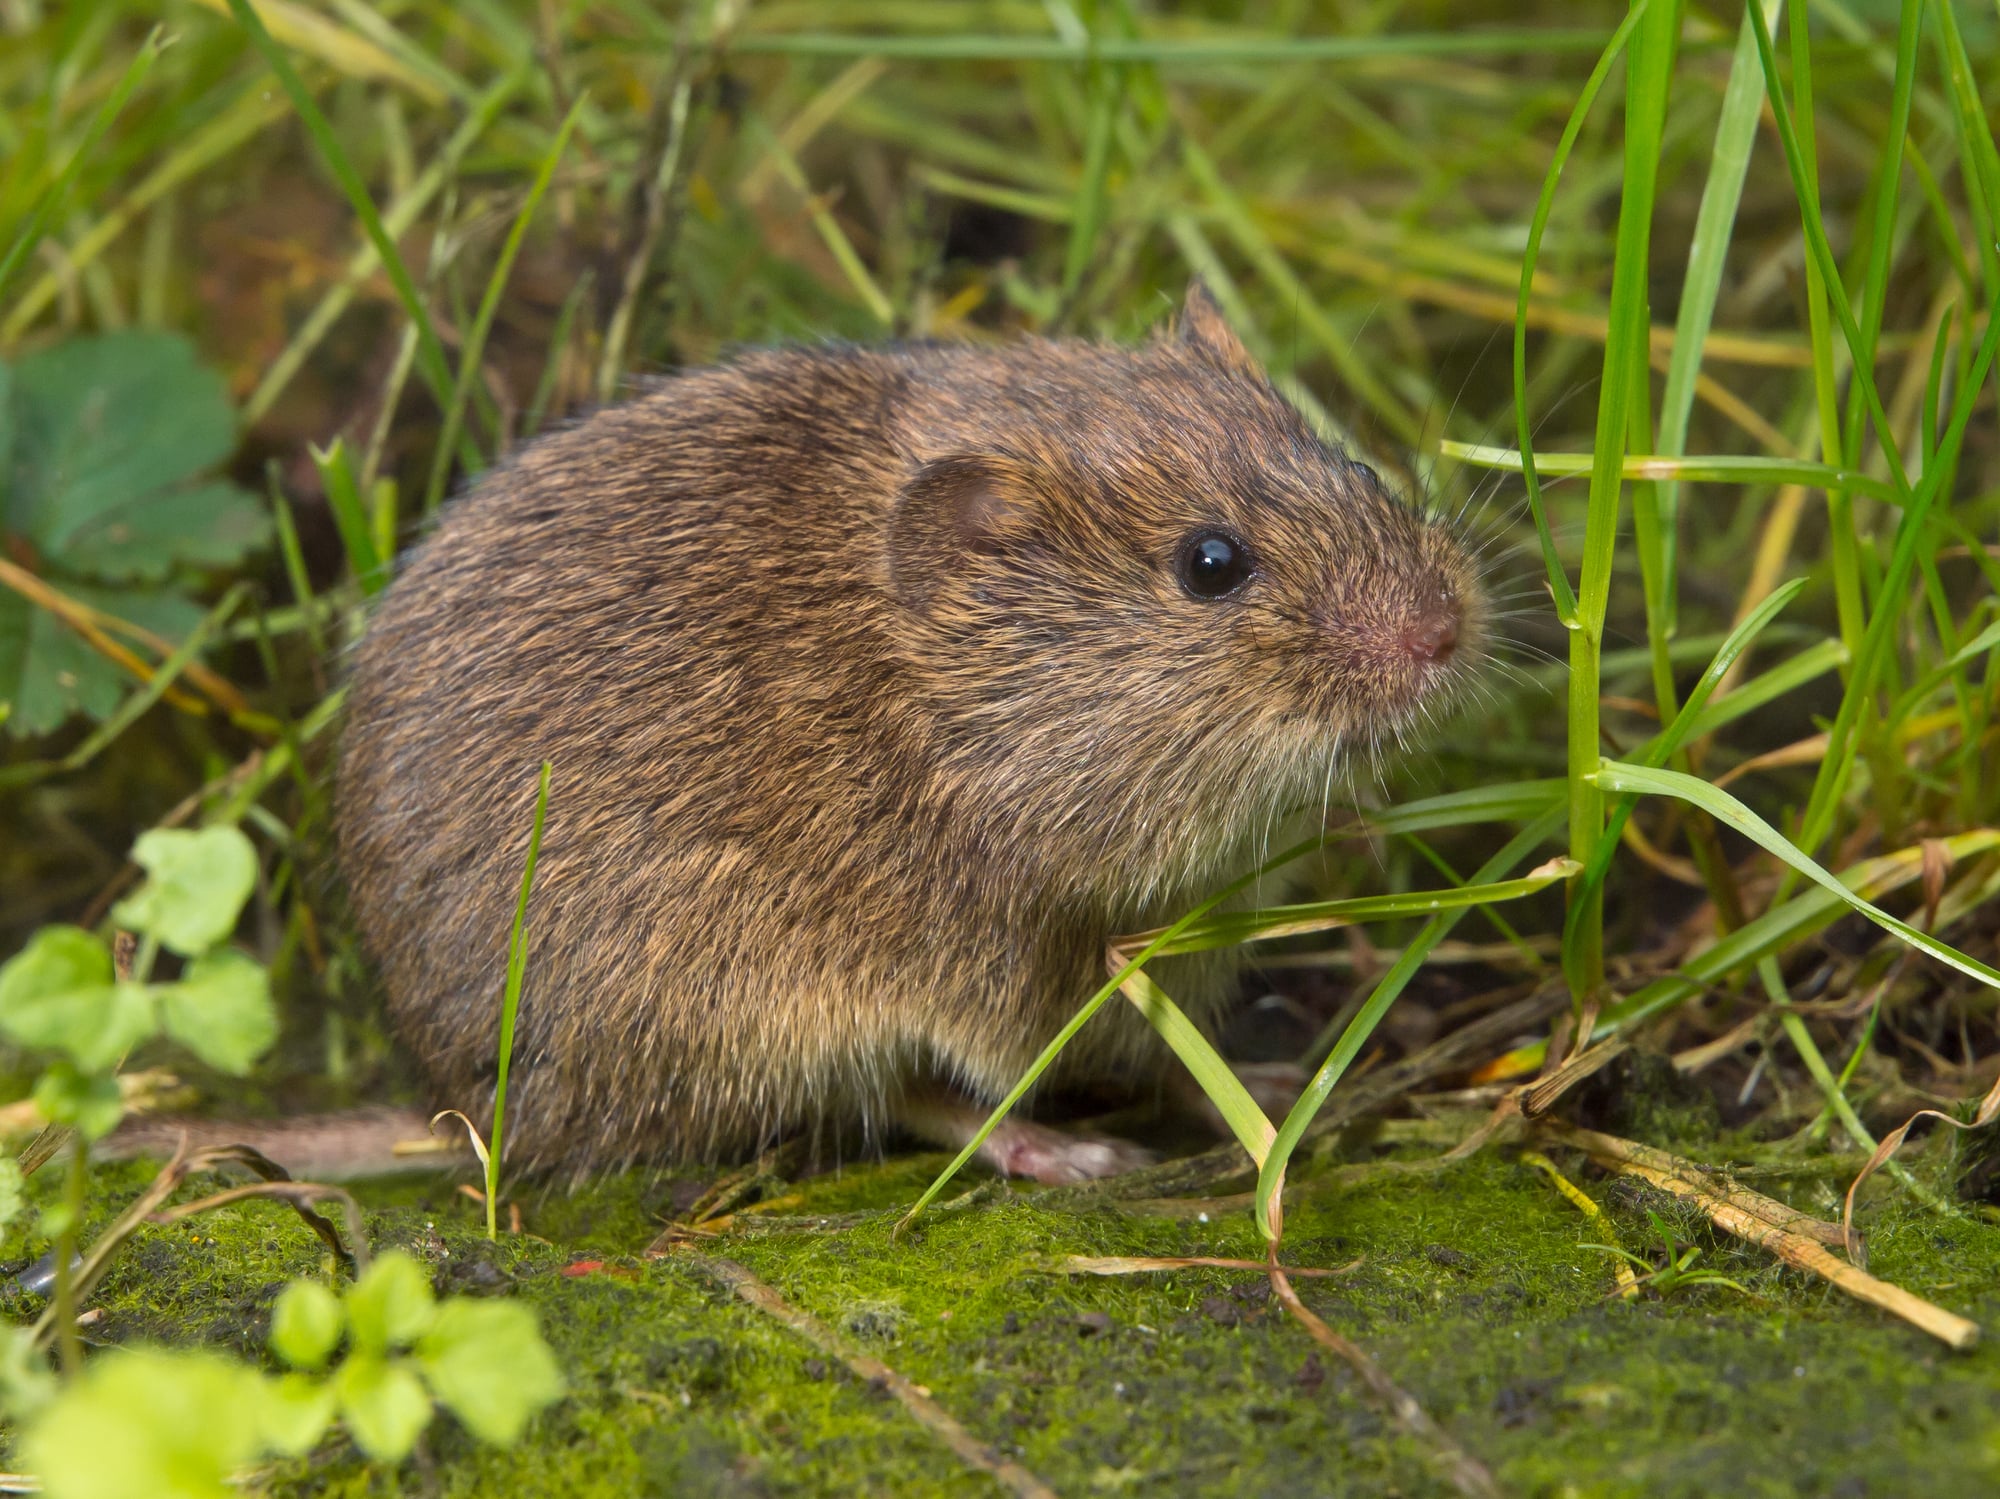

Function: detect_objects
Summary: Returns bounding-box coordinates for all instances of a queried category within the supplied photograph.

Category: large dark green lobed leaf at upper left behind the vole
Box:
[0,330,264,578]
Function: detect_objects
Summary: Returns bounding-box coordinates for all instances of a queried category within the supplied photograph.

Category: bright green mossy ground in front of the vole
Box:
[19,1119,2000,1499]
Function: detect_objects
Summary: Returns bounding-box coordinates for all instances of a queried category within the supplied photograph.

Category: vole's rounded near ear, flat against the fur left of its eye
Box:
[888,454,1036,610]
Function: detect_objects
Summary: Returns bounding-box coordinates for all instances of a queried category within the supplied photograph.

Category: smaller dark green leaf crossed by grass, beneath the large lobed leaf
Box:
[0,582,202,740]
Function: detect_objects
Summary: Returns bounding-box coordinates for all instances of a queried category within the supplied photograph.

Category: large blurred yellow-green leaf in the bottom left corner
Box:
[18,1349,262,1499]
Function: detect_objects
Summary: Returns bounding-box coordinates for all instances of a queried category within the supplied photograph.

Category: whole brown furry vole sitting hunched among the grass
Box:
[338,286,1482,1179]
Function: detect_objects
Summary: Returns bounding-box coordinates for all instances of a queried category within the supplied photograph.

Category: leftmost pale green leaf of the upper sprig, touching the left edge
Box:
[0,925,158,1071]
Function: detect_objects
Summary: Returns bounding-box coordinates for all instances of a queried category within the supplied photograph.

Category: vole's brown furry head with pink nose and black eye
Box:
[888,286,1486,887]
